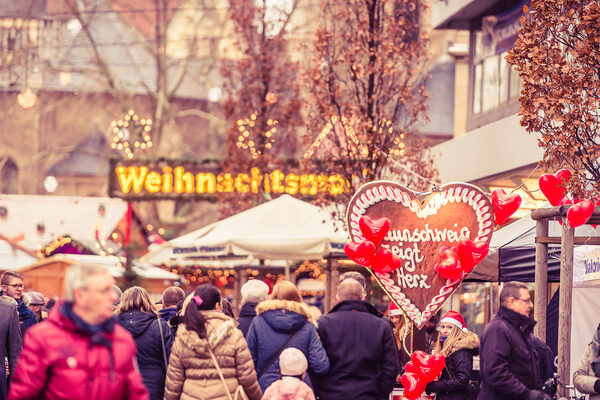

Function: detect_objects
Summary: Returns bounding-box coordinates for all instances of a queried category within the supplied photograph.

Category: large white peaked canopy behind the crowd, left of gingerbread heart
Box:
[161,194,348,262]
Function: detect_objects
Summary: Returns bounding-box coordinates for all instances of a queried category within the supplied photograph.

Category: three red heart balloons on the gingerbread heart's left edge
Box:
[344,215,402,274]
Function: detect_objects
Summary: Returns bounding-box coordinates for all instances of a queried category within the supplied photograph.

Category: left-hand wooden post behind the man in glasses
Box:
[533,219,548,342]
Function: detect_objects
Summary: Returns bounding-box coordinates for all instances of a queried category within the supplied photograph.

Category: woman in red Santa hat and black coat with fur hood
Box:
[425,311,479,400]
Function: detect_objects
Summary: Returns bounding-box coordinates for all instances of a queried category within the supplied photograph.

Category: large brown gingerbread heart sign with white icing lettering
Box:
[347,181,494,329]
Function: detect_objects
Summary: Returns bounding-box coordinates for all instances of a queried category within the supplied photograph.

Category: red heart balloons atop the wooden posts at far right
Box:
[539,169,600,228]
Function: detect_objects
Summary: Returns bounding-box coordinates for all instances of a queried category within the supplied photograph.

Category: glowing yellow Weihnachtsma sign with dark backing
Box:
[109,160,348,199]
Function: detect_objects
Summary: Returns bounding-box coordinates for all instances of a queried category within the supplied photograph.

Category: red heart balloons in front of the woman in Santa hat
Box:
[400,350,446,400]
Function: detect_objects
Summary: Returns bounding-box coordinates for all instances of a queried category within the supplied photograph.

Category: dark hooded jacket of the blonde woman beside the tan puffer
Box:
[117,310,173,400]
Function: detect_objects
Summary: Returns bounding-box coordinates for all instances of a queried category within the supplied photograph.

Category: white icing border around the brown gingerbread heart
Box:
[347,181,494,328]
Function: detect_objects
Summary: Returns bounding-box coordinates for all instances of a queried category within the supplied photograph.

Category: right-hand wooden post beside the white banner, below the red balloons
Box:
[558,220,575,397]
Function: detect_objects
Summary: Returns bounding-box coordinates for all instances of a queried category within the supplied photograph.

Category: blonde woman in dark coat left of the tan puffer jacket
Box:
[117,286,173,400]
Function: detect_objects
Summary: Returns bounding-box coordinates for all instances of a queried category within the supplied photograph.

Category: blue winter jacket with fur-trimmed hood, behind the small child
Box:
[246,300,329,390]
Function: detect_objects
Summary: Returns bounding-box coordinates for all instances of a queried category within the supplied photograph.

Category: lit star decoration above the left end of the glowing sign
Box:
[110,110,152,158]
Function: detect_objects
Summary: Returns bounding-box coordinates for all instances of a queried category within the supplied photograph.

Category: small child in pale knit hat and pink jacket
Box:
[262,347,315,400]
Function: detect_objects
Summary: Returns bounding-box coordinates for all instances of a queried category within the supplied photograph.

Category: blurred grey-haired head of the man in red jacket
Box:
[65,264,117,324]
